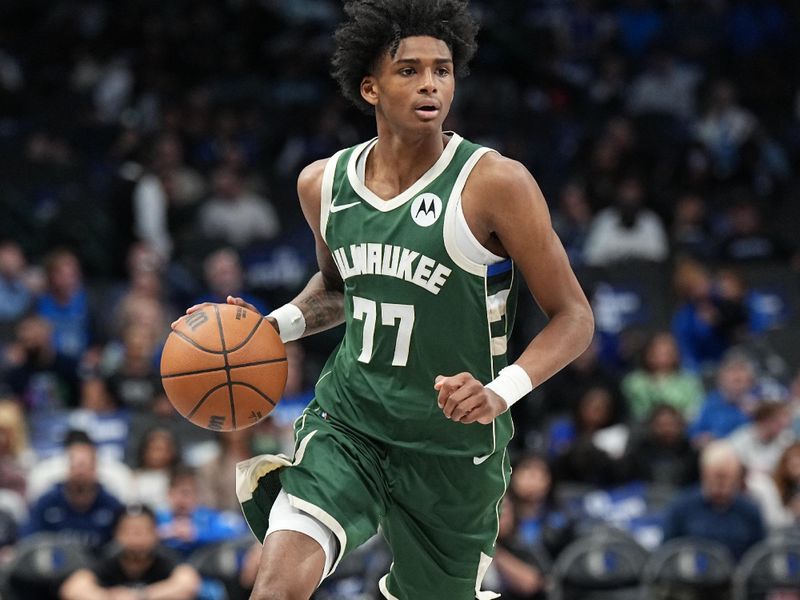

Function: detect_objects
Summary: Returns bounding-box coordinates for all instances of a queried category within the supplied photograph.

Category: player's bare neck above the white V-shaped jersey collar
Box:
[366,122,446,197]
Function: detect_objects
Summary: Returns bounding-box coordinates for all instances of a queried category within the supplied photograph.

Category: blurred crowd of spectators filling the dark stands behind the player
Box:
[0,0,800,600]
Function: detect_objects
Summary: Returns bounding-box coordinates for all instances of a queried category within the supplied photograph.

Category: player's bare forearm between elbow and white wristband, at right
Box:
[516,303,594,387]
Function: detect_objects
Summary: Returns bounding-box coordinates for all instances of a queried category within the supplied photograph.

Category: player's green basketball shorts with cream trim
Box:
[236,402,511,600]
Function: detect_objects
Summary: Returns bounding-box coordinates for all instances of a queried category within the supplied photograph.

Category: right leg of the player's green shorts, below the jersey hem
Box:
[381,452,510,600]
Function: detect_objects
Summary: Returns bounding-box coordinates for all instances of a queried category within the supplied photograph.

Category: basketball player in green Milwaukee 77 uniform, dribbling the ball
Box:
[181,0,593,600]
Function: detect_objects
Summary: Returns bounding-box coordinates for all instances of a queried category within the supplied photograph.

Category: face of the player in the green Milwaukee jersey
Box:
[361,36,455,131]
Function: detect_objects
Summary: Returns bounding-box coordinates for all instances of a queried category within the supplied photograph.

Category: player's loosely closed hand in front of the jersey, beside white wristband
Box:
[433,373,508,425]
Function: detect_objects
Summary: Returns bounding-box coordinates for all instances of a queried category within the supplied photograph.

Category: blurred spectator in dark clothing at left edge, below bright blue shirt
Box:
[5,315,78,413]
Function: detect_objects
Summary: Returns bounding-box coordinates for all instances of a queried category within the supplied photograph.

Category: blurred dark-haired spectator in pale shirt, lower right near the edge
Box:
[728,400,795,473]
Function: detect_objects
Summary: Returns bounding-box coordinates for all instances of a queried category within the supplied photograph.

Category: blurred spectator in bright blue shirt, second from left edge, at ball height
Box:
[36,248,92,359]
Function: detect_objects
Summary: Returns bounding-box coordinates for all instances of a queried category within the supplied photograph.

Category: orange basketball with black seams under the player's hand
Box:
[161,304,287,431]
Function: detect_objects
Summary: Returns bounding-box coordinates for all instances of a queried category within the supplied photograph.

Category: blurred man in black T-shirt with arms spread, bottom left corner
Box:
[59,506,200,600]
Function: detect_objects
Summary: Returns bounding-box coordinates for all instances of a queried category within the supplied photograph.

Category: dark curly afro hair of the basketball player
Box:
[332,0,478,113]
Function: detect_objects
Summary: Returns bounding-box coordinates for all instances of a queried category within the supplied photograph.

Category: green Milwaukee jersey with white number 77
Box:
[316,134,517,464]
